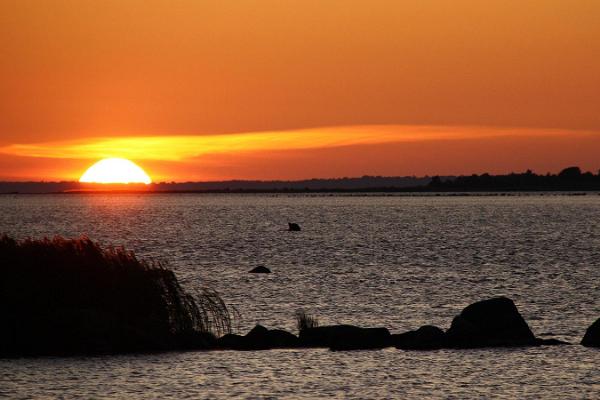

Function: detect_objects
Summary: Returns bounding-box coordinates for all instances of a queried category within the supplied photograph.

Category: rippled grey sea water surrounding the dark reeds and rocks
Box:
[0,194,600,399]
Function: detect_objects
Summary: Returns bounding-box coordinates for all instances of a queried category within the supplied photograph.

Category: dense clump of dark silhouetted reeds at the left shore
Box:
[0,235,231,356]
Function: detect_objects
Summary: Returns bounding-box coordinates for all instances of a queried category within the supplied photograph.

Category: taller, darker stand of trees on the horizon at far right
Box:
[426,167,600,192]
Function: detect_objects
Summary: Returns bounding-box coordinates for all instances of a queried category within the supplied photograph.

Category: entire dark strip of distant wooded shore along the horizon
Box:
[0,167,600,193]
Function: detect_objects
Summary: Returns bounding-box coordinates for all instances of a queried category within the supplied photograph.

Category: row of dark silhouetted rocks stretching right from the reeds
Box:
[216,297,576,351]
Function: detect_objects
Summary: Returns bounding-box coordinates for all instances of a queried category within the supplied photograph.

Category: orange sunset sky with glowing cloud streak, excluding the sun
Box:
[0,0,600,181]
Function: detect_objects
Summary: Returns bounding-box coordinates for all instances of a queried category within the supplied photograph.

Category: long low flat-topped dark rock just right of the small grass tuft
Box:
[299,325,391,351]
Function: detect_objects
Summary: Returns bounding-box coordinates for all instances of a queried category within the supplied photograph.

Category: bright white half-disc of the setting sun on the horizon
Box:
[79,158,152,184]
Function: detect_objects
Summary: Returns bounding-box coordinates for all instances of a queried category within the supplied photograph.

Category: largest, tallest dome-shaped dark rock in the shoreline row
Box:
[446,297,537,348]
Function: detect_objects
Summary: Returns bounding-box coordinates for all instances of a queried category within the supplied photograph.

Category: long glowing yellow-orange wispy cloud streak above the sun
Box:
[0,125,584,161]
